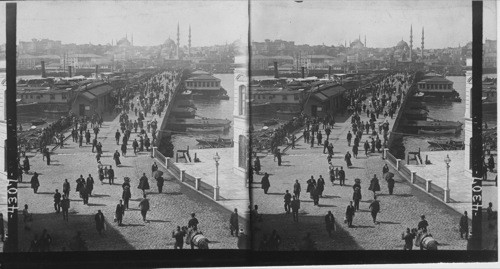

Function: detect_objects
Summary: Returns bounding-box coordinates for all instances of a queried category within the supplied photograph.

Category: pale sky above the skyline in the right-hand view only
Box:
[251,0,497,49]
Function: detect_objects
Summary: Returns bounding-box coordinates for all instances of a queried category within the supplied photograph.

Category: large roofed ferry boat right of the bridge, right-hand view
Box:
[416,74,462,102]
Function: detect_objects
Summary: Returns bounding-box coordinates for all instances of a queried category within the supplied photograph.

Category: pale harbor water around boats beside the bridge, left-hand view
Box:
[172,74,234,152]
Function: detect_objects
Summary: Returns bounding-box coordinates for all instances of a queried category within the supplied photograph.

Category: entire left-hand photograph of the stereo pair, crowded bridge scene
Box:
[0,1,250,252]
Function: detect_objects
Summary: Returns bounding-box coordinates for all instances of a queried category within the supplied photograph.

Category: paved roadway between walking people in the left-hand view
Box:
[18,73,245,251]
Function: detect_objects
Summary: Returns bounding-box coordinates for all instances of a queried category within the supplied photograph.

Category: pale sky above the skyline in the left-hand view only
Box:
[7,0,248,47]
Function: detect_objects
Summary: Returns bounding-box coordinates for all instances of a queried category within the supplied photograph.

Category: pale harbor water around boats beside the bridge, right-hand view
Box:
[403,74,497,152]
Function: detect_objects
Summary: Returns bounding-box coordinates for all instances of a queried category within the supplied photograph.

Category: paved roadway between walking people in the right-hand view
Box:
[252,75,467,250]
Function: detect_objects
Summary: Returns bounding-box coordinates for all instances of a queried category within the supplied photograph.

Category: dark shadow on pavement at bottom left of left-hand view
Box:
[18,213,135,252]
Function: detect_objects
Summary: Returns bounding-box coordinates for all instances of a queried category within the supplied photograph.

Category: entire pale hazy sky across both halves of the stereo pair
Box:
[0,0,497,48]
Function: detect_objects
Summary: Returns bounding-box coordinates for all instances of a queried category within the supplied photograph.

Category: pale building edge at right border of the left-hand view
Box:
[233,54,250,178]
